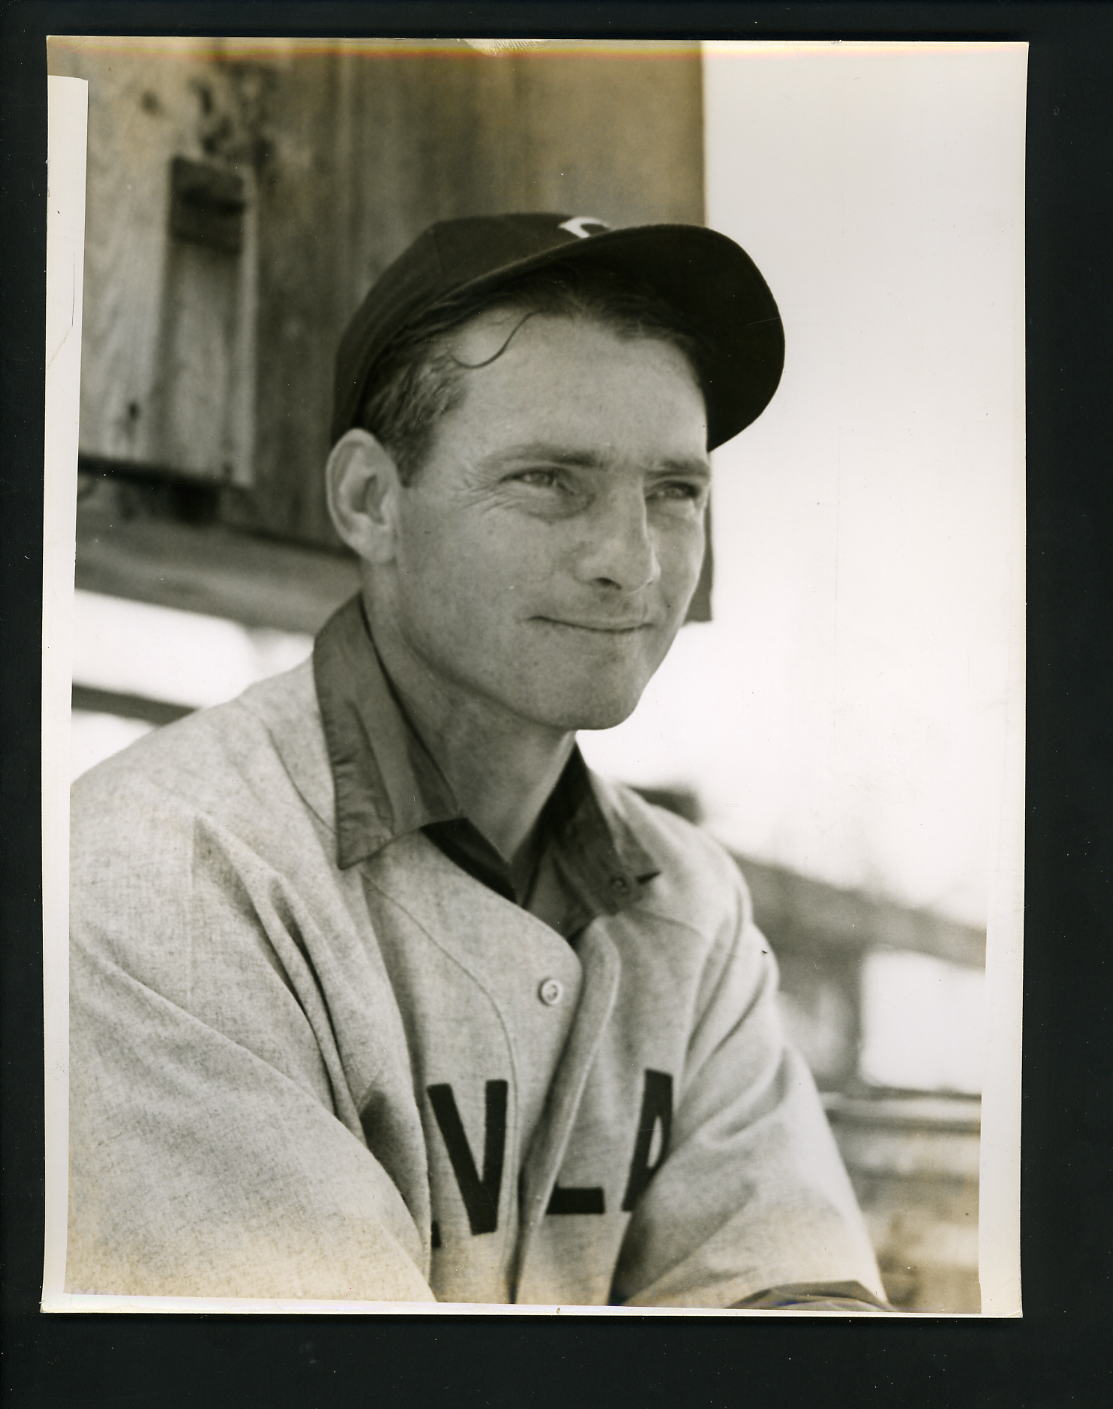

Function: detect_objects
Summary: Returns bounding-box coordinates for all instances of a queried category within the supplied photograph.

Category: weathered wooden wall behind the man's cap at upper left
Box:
[49,38,703,624]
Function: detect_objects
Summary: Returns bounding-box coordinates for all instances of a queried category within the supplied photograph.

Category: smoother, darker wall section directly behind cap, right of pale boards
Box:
[241,42,703,544]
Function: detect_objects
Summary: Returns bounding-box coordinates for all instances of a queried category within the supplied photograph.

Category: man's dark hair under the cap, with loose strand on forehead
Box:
[355,266,702,485]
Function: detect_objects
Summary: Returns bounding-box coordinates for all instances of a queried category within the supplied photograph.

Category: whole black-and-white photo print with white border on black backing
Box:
[44,35,1026,1317]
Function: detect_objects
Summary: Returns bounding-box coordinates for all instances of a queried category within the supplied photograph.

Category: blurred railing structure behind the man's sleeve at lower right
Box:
[644,789,985,1312]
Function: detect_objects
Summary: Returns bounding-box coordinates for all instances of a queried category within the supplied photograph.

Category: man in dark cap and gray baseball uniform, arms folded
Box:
[68,214,879,1309]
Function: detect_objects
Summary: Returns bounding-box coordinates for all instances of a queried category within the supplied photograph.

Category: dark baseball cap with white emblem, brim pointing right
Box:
[332,214,785,449]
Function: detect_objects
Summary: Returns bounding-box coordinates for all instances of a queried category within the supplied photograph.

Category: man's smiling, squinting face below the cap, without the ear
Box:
[383,311,709,733]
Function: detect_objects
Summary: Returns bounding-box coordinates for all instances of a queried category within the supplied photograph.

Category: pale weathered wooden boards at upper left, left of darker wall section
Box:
[49,38,262,483]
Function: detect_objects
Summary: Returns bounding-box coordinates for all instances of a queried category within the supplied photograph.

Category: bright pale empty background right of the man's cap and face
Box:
[583,45,1024,926]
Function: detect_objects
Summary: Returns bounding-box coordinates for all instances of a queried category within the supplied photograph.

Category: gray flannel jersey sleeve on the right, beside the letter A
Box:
[614,857,883,1308]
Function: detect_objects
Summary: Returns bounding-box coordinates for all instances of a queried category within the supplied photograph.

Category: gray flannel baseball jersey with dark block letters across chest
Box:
[66,622,879,1308]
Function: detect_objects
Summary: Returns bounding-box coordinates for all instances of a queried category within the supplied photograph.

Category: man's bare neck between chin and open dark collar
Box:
[371,597,575,862]
